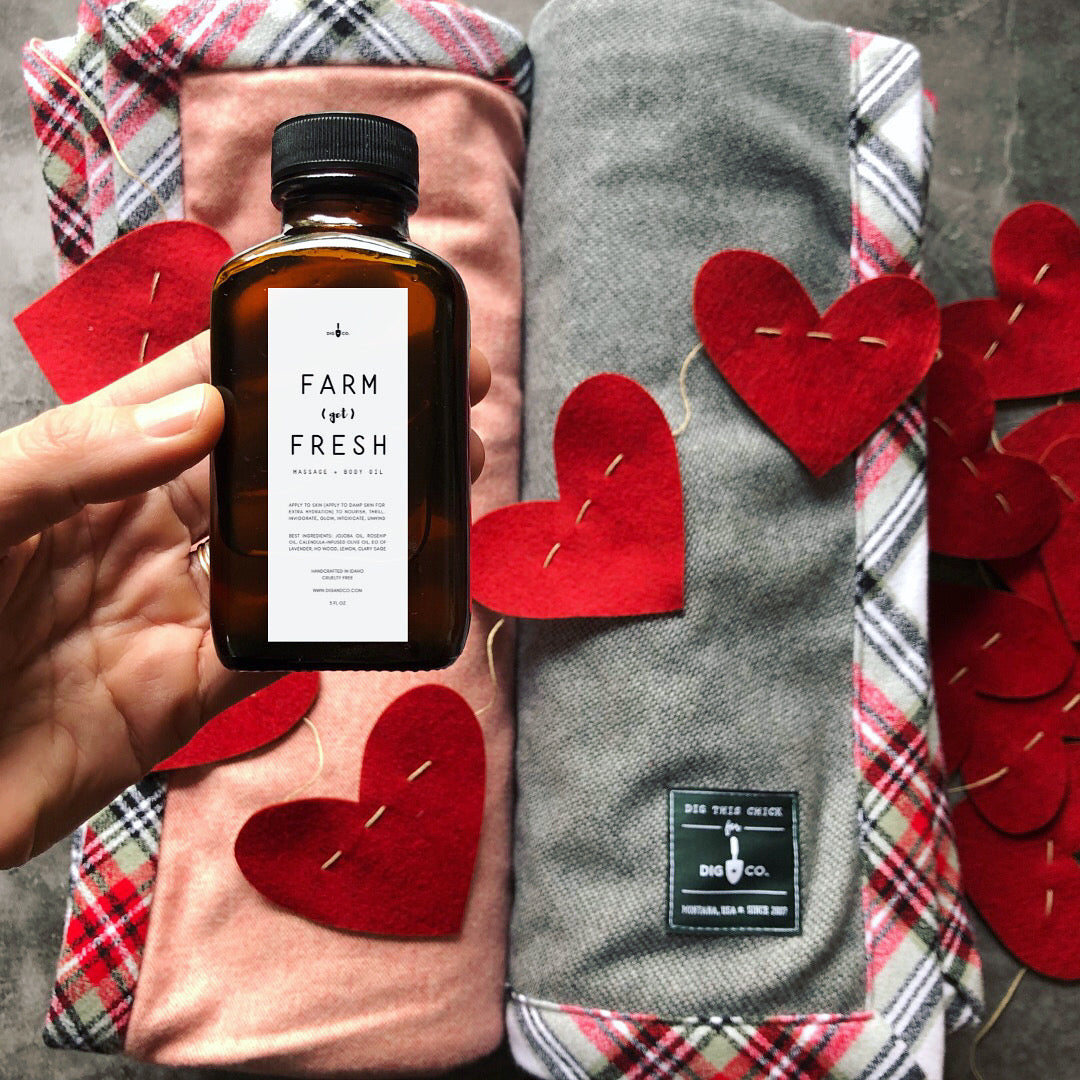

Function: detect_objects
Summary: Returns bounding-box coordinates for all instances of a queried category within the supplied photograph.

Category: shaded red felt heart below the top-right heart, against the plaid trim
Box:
[927,356,1057,558]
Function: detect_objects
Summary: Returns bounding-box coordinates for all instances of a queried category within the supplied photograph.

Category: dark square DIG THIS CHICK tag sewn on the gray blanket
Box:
[667,787,802,934]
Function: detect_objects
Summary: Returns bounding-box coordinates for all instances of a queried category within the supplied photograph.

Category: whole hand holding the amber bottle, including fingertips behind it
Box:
[0,335,490,867]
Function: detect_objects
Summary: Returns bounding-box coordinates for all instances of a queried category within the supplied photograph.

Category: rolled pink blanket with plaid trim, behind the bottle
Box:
[26,0,529,1076]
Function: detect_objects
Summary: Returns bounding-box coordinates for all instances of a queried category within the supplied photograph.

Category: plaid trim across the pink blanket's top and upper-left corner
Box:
[23,0,532,270]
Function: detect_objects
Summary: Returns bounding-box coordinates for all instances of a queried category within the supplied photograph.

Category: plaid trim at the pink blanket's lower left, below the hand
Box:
[43,777,165,1052]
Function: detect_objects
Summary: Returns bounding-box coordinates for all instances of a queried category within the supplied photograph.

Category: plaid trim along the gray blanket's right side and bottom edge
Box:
[507,25,981,1080]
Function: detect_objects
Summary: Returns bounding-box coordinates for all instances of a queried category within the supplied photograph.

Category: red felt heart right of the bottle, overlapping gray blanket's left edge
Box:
[472,375,685,619]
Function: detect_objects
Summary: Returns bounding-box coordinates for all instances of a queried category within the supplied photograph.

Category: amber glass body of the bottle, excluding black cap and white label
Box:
[211,185,470,670]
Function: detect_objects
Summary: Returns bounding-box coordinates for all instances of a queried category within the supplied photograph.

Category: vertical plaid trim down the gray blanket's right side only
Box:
[850,31,982,1036]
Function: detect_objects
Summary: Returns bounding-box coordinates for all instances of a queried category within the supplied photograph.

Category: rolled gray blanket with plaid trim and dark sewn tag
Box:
[509,0,977,1077]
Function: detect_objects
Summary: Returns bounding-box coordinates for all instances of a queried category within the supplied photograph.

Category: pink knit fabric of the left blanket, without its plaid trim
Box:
[126,67,525,1076]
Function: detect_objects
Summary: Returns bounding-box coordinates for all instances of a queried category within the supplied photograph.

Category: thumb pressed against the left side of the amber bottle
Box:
[0,383,225,553]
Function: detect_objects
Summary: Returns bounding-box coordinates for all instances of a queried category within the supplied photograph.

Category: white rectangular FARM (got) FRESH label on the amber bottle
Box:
[267,288,408,642]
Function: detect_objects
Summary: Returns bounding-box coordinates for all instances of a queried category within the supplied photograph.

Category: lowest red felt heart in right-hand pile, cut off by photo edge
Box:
[953,746,1080,978]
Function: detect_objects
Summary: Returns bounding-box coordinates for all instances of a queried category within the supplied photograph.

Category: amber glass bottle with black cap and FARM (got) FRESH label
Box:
[210,112,469,671]
